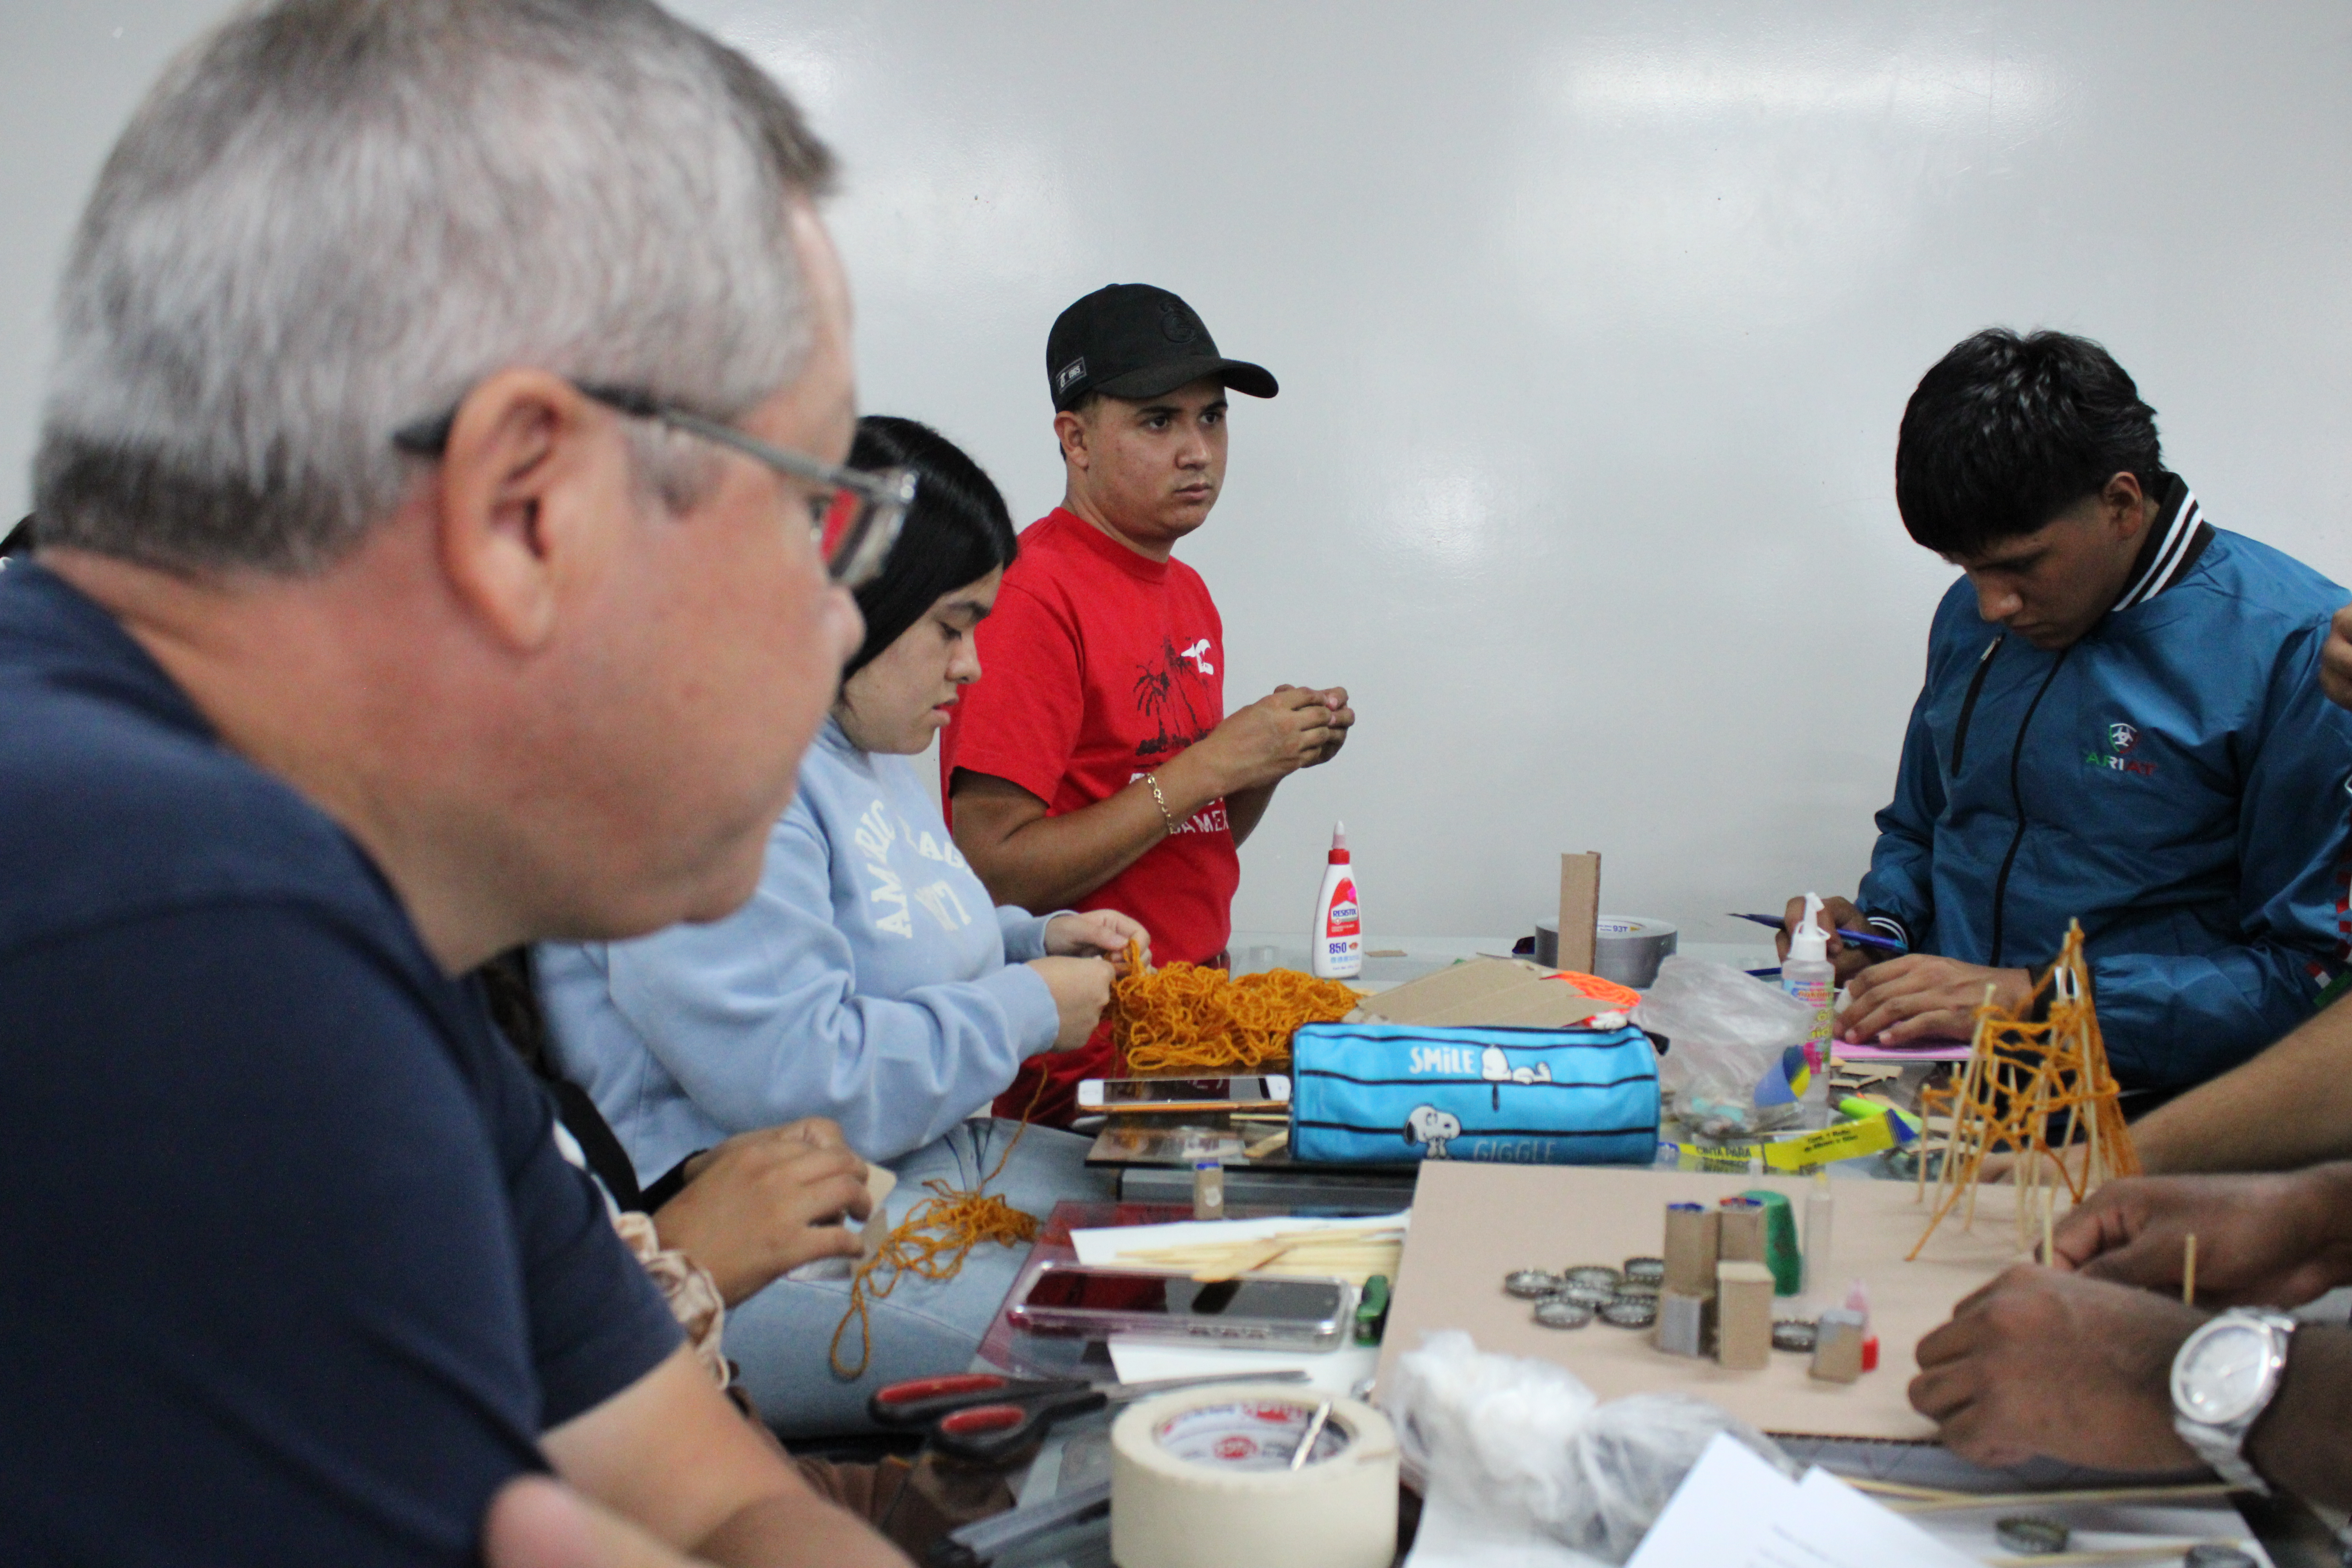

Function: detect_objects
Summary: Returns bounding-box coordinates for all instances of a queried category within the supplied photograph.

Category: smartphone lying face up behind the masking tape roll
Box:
[1007,1262,1355,1349]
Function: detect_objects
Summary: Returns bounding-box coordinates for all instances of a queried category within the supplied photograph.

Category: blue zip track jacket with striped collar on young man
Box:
[1860,479,2352,1089]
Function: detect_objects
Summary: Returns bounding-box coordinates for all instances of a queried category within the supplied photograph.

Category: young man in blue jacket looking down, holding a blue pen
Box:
[1783,329,2352,1091]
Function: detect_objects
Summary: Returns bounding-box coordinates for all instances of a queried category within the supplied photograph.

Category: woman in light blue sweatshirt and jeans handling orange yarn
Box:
[539,416,1145,1434]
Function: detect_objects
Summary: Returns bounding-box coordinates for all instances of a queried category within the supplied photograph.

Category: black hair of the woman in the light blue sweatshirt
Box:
[842,414,1021,679]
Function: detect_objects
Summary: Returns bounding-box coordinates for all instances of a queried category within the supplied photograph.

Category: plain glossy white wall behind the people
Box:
[0,0,2352,940]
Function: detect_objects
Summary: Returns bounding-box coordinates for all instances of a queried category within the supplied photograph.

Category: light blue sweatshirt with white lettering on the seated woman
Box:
[539,719,1058,1182]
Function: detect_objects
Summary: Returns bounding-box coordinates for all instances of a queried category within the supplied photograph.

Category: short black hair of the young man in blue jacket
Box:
[1896,327,2169,559]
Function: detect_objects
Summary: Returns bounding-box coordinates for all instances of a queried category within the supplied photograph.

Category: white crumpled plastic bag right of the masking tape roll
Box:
[1385,1330,1797,1568]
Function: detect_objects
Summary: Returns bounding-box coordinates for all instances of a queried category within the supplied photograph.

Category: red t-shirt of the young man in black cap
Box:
[938,508,1242,1124]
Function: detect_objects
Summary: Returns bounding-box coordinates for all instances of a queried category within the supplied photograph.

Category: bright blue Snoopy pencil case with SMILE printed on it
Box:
[1291,1023,1658,1166]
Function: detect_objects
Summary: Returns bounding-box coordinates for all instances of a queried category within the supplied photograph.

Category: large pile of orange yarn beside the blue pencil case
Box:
[1110,943,1362,1077]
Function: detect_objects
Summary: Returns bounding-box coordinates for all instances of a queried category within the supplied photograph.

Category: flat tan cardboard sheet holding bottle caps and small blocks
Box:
[1381,1159,2018,1441]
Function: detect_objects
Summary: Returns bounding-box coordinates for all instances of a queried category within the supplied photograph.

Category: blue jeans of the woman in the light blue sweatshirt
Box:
[727,1119,1117,1436]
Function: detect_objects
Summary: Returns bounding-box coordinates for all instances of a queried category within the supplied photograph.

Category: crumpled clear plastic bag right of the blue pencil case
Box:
[1635,955,1813,1138]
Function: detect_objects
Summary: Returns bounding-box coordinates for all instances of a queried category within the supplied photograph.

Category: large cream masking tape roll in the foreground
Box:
[1110,1382,1397,1568]
